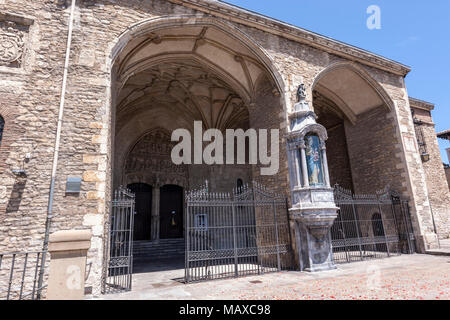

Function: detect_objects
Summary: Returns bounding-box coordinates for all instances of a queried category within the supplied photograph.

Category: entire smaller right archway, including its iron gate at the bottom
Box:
[312,62,410,263]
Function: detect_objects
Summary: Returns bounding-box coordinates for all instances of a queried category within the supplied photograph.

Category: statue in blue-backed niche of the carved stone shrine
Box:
[305,135,324,186]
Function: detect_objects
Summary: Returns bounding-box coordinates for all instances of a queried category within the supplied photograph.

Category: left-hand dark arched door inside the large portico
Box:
[128,183,152,241]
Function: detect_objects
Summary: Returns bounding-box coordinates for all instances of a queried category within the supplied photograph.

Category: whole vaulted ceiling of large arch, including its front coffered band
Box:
[115,25,276,134]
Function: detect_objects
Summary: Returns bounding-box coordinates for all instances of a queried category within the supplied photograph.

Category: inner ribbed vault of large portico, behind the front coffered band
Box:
[117,60,249,134]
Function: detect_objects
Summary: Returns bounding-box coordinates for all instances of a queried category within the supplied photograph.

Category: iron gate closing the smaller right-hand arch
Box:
[331,185,415,263]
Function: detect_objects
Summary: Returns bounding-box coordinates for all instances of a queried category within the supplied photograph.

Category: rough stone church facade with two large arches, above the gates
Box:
[0,0,450,293]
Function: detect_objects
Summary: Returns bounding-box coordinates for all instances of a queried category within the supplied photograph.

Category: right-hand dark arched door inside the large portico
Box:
[159,184,183,239]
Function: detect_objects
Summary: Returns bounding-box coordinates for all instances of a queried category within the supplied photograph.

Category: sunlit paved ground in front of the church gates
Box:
[96,254,450,300]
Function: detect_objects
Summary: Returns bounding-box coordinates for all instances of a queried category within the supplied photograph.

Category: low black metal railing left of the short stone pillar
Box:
[0,252,47,300]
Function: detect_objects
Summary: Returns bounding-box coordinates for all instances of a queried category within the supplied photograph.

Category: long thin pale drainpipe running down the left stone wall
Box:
[37,0,76,299]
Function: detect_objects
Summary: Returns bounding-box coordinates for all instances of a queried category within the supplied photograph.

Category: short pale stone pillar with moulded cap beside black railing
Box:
[46,230,91,300]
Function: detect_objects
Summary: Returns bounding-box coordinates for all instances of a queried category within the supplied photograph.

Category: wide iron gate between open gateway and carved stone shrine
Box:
[185,182,293,282]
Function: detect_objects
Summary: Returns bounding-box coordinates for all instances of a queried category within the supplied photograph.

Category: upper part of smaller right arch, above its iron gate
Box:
[313,63,402,194]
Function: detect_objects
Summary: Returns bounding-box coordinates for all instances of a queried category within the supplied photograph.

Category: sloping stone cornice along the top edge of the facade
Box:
[169,0,411,76]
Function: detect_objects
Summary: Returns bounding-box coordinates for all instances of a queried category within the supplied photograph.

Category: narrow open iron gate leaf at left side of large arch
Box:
[103,187,135,293]
